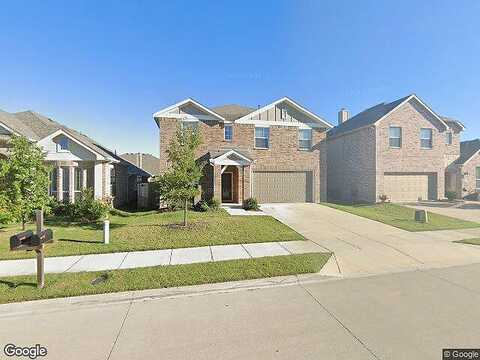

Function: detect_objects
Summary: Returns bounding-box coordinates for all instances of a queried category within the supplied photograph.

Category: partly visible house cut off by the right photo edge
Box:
[447,139,480,200]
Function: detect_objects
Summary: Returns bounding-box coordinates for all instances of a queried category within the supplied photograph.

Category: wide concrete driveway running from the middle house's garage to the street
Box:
[262,204,480,277]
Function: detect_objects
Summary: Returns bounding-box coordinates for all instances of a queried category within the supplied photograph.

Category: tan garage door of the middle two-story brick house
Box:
[253,171,313,203]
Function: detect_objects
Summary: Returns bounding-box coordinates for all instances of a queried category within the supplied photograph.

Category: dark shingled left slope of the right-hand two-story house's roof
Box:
[328,95,411,137]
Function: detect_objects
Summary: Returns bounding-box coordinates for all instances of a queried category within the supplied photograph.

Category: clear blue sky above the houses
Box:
[0,0,480,154]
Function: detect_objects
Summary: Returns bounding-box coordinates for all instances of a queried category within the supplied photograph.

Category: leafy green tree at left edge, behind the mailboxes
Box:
[0,136,50,230]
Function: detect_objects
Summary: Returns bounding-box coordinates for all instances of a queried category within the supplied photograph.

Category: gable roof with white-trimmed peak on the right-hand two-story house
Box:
[328,94,449,137]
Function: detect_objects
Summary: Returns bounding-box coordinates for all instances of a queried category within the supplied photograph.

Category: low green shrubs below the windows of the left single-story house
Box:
[52,189,111,222]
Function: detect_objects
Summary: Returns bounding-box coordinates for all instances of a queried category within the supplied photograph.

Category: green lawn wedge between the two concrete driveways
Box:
[323,203,480,231]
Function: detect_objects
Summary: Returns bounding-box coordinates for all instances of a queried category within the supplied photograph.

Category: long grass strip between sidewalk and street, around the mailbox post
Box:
[0,253,331,303]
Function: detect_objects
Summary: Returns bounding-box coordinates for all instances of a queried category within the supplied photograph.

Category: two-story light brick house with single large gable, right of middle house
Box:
[327,95,464,203]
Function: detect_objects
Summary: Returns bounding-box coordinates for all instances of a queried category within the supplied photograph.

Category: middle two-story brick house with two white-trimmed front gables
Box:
[153,97,332,203]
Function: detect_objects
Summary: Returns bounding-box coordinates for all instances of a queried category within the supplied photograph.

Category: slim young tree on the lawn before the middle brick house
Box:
[156,128,205,226]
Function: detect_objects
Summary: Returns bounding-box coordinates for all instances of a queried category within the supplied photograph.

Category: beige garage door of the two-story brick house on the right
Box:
[384,174,435,202]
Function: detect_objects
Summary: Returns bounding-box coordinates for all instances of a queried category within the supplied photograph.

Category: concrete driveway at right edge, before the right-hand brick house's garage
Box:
[408,201,480,222]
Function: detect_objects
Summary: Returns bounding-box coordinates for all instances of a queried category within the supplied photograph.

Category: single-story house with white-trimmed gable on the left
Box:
[0,110,150,206]
